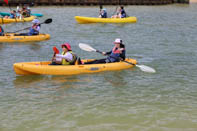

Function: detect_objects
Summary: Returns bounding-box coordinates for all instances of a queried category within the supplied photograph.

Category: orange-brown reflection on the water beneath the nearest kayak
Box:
[13,75,86,89]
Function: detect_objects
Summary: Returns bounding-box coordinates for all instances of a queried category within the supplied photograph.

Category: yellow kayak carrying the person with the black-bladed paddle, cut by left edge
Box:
[0,33,50,43]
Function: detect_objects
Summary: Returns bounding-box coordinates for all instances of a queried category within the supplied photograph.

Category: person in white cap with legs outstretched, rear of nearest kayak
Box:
[84,38,126,64]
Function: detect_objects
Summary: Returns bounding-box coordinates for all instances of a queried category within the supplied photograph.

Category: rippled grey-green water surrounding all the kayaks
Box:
[0,4,197,131]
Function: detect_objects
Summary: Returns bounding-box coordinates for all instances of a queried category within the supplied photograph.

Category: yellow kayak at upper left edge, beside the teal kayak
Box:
[0,16,36,24]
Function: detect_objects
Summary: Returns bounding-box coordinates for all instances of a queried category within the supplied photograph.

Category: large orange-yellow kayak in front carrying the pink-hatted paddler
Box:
[13,59,137,75]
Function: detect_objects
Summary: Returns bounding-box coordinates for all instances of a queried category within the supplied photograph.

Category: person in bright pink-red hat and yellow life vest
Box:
[49,43,81,65]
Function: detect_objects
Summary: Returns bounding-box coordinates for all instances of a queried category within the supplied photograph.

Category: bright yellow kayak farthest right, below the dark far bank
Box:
[75,16,137,24]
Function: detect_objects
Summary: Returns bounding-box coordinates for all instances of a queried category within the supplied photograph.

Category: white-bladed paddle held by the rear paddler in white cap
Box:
[79,43,156,73]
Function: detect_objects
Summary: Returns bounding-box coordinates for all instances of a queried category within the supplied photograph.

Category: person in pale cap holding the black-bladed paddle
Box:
[15,19,41,36]
